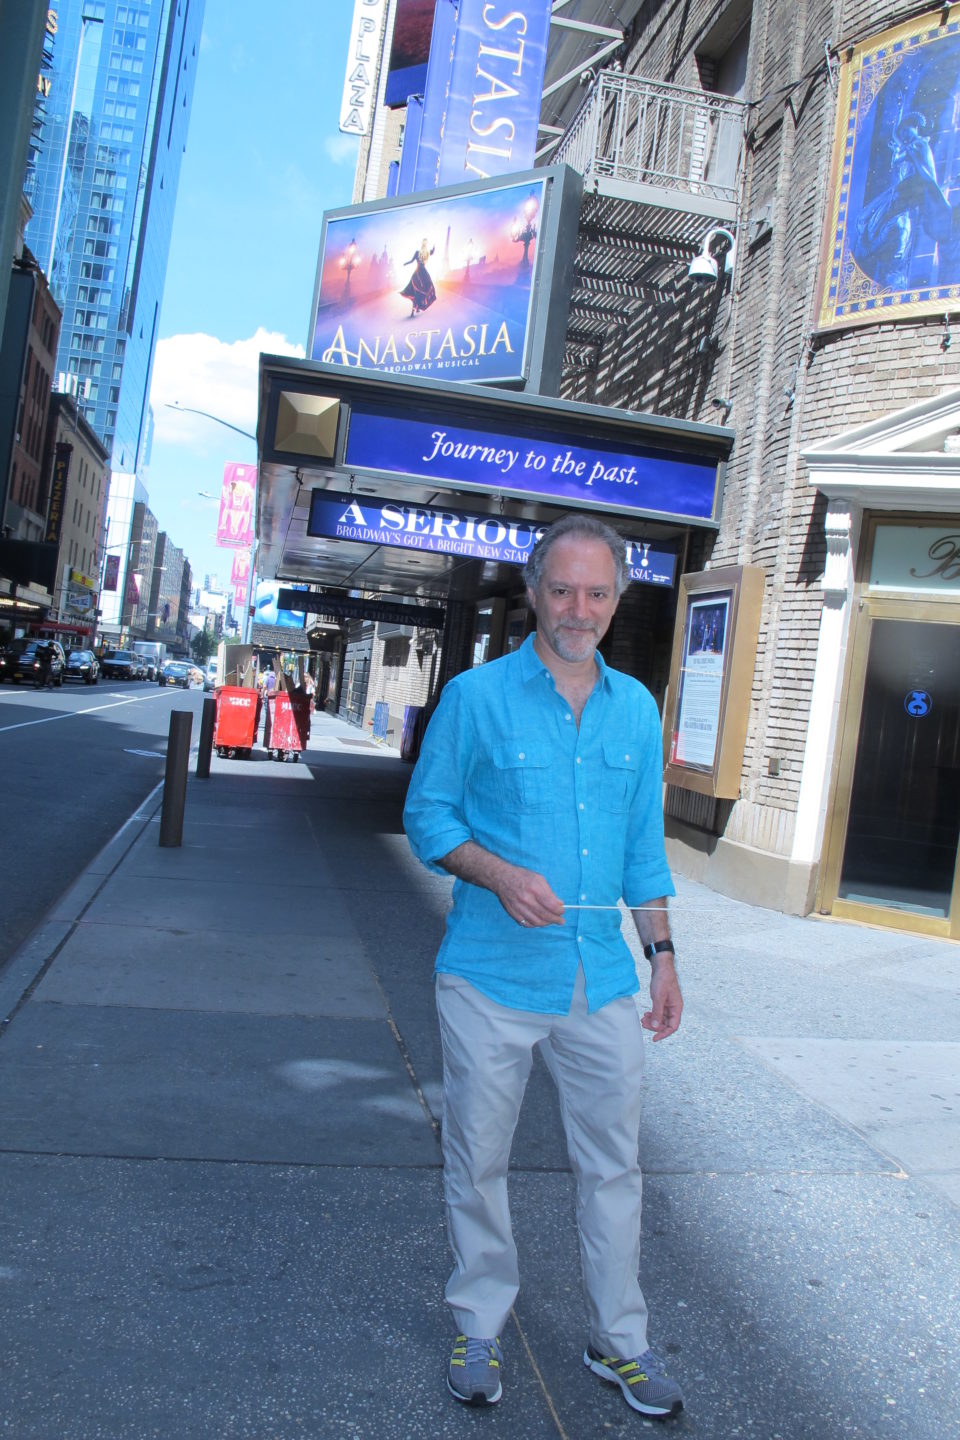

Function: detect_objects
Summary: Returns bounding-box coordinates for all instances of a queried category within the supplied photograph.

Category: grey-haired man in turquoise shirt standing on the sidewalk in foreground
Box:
[404,514,684,1416]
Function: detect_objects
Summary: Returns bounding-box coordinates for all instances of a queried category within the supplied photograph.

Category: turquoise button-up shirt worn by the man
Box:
[403,636,674,1015]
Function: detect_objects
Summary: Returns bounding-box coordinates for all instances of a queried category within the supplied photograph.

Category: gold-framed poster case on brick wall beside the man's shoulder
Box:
[664,566,763,799]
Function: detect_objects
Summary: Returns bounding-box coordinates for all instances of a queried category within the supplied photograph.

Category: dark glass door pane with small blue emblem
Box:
[838,619,960,916]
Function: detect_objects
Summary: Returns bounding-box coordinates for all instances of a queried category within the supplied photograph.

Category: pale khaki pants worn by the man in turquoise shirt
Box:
[436,969,646,1358]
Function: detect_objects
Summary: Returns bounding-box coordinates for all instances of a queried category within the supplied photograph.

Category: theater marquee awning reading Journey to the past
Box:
[256,356,734,598]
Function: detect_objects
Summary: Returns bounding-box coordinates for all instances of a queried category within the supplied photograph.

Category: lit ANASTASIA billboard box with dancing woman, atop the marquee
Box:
[308,166,583,395]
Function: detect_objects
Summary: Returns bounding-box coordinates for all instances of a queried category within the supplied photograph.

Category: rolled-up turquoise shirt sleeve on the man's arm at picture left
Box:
[403,680,474,874]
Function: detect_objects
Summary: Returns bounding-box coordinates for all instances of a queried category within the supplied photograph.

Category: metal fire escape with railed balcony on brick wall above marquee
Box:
[538,0,747,388]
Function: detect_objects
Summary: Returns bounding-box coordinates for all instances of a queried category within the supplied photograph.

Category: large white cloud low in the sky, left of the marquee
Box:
[150,328,304,454]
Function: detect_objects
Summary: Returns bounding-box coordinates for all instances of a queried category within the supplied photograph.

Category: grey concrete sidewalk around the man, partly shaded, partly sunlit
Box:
[0,716,960,1440]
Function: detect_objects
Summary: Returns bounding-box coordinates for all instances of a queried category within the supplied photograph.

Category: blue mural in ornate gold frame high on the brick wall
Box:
[818,4,960,330]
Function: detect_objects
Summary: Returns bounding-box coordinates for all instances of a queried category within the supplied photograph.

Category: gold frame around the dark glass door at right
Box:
[816,513,960,939]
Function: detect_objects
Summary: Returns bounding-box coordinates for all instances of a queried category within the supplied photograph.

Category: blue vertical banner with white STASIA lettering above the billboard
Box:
[436,0,551,186]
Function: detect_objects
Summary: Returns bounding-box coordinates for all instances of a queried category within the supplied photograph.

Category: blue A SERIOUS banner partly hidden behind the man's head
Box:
[307,490,676,585]
